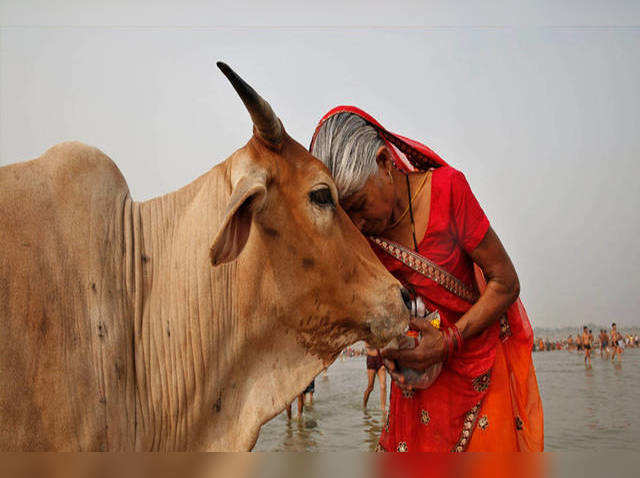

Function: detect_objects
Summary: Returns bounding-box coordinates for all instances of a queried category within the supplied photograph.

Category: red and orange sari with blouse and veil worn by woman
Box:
[312,106,543,452]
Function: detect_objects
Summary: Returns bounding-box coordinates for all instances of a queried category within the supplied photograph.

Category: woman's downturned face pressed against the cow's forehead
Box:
[340,161,396,236]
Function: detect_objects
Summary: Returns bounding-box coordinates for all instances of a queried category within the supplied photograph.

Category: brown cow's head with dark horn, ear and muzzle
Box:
[210,63,409,357]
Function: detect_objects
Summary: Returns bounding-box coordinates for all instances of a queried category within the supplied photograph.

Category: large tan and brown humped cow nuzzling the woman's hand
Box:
[0,63,409,451]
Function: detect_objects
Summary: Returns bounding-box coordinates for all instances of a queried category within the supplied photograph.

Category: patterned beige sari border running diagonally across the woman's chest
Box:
[370,237,479,304]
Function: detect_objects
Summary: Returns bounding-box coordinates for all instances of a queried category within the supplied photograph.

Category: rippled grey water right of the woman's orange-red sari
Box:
[534,349,640,451]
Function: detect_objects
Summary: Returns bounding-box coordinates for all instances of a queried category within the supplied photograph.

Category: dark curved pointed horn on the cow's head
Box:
[216,61,282,145]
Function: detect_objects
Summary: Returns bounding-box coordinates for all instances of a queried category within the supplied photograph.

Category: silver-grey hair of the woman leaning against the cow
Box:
[311,112,384,199]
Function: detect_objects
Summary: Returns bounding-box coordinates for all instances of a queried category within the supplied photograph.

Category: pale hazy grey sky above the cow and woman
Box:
[0,0,640,326]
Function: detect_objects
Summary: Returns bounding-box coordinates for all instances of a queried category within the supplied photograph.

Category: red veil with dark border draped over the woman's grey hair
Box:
[309,105,447,173]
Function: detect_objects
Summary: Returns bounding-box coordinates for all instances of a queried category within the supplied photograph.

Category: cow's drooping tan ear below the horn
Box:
[210,171,267,266]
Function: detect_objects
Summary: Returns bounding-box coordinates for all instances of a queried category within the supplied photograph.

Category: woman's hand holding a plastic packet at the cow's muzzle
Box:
[381,319,445,374]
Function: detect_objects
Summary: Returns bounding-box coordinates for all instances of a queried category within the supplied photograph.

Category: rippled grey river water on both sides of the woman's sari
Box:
[255,349,640,451]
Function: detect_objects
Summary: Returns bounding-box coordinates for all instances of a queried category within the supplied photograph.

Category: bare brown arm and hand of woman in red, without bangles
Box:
[382,228,520,370]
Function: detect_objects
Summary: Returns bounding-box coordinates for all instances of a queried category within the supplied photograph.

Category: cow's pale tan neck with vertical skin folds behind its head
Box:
[127,168,327,450]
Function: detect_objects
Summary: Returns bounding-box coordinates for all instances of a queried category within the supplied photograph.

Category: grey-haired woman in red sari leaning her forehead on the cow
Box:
[310,106,543,452]
